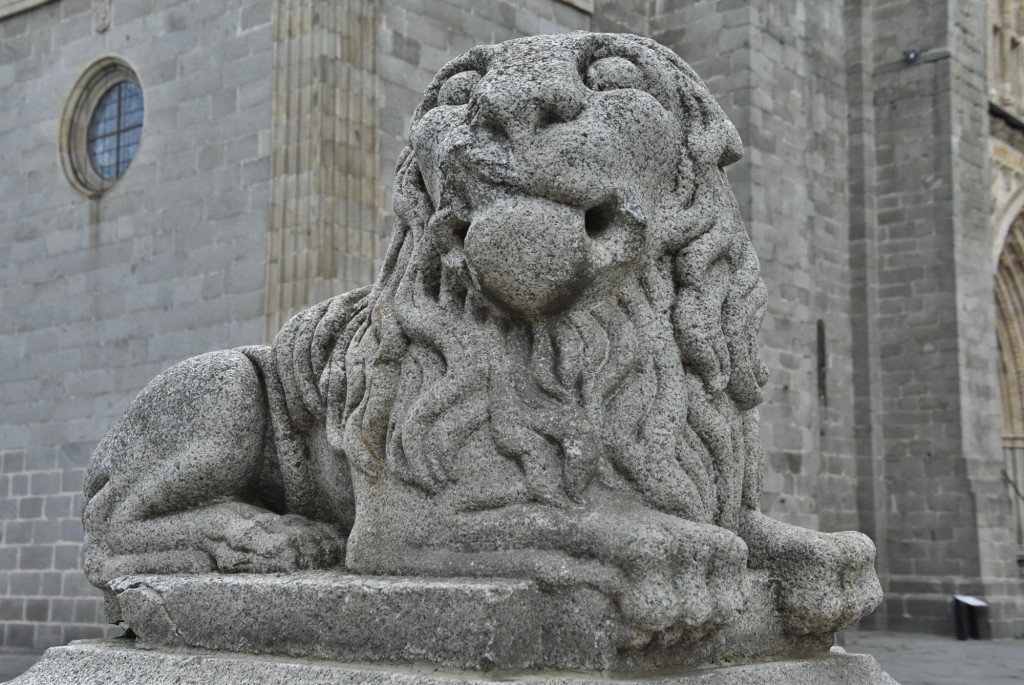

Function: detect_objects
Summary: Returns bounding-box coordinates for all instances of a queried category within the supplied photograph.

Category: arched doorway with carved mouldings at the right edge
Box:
[995,213,1024,549]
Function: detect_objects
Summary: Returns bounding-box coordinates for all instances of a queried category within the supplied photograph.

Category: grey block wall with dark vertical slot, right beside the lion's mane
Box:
[650,0,858,530]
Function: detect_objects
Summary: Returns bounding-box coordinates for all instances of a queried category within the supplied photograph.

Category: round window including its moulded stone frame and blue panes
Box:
[60,57,144,197]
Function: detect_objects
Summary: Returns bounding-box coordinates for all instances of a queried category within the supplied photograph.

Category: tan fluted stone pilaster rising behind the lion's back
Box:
[264,0,382,335]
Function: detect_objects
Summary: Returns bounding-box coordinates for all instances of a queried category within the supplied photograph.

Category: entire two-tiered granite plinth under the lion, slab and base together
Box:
[12,571,895,685]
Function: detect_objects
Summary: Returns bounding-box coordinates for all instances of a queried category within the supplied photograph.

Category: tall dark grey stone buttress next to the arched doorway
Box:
[850,0,1024,637]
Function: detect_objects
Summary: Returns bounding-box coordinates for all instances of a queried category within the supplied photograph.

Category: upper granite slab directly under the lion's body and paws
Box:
[101,571,833,672]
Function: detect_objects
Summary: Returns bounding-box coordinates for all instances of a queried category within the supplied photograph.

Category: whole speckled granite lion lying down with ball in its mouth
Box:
[84,32,881,640]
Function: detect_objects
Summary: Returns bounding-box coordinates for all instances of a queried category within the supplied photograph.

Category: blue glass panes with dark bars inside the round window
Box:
[86,81,143,181]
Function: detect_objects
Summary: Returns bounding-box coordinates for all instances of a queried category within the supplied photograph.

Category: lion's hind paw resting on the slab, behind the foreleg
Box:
[207,512,345,573]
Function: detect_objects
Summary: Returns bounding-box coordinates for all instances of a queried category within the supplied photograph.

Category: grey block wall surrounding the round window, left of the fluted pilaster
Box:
[0,0,273,650]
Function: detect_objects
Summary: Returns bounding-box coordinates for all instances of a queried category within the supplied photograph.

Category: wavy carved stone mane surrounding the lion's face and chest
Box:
[274,36,767,529]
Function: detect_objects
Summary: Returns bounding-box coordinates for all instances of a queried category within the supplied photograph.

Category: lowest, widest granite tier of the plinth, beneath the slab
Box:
[9,639,896,685]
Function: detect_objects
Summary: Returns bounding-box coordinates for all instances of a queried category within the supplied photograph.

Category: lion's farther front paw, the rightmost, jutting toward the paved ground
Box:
[743,513,882,635]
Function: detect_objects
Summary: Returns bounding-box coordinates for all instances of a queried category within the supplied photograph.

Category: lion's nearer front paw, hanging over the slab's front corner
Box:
[618,519,749,643]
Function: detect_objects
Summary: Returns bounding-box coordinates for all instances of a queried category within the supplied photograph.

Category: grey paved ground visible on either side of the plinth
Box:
[0,633,1024,685]
